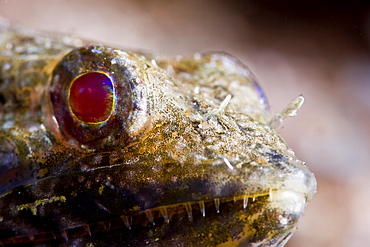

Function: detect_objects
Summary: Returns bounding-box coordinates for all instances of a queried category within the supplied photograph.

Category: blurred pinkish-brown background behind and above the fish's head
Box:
[0,0,370,247]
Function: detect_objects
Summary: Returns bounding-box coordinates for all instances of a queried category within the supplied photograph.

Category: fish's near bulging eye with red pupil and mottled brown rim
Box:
[46,46,148,149]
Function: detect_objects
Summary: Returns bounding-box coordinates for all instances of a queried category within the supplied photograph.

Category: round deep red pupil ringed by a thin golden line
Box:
[69,72,113,123]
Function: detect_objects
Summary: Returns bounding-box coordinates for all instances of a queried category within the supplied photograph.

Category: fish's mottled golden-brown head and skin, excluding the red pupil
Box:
[0,24,316,246]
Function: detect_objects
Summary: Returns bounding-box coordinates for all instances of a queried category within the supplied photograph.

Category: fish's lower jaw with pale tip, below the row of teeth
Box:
[0,191,305,246]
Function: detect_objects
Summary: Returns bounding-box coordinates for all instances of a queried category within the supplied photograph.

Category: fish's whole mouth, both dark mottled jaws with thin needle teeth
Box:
[0,158,316,246]
